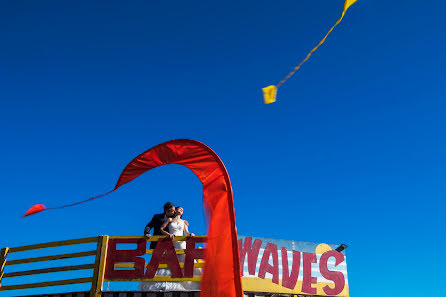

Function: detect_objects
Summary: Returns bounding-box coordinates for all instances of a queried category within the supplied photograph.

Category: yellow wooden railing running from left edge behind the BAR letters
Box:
[0,235,204,297]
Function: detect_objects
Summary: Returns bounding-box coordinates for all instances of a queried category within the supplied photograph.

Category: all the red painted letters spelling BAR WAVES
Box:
[105,237,345,296]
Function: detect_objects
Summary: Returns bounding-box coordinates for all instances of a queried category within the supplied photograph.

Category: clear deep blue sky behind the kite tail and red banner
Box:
[0,0,446,297]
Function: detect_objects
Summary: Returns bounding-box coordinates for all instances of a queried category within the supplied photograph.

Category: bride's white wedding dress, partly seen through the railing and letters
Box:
[139,220,201,291]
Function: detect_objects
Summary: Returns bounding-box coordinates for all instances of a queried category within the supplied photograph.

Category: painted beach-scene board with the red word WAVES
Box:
[238,236,349,297]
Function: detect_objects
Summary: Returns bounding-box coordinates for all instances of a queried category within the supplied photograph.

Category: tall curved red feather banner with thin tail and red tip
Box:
[24,139,243,297]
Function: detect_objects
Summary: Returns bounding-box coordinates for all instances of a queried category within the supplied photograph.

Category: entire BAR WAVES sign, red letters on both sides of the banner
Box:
[104,236,349,297]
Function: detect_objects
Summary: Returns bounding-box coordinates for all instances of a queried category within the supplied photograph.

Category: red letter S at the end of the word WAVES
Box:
[319,251,345,295]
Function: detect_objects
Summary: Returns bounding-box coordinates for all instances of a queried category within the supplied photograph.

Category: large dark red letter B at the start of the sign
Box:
[105,238,146,279]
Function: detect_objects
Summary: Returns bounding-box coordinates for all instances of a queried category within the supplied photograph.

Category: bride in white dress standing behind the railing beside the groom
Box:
[139,206,201,291]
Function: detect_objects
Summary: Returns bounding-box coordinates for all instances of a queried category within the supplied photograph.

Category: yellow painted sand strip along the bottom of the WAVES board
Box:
[242,277,349,297]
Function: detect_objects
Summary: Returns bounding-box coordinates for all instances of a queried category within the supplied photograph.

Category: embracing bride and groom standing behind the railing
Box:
[144,202,194,249]
